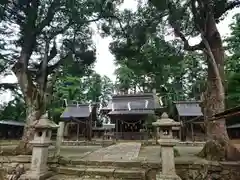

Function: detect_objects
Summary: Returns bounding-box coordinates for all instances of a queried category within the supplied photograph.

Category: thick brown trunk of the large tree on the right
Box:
[199,10,240,160]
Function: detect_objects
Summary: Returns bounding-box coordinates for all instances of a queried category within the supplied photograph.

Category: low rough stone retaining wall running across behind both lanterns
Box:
[0,156,240,180]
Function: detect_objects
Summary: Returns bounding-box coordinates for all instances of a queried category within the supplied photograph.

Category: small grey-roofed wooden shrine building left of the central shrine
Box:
[60,103,97,140]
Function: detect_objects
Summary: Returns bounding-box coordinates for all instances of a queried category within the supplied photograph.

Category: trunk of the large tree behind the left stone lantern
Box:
[13,59,46,154]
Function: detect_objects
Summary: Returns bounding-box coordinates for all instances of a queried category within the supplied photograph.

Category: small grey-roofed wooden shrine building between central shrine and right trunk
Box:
[170,101,205,141]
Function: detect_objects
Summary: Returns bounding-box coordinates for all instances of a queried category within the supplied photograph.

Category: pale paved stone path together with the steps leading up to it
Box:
[48,143,156,180]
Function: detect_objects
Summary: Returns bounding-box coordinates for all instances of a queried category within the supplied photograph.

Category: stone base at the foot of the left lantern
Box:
[19,171,53,180]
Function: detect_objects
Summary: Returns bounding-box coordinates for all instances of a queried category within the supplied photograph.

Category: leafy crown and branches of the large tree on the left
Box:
[0,0,121,126]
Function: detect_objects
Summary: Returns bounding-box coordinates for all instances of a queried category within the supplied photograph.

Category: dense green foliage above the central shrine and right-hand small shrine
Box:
[107,0,240,111]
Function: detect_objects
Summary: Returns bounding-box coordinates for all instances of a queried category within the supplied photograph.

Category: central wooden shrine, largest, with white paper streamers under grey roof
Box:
[100,93,161,139]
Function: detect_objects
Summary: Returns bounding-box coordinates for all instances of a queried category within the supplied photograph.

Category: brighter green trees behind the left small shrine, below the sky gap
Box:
[49,69,113,121]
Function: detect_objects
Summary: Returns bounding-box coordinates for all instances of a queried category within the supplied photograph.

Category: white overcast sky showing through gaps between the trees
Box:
[0,0,239,104]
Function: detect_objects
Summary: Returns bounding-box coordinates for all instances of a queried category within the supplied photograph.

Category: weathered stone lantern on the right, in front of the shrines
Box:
[153,113,181,180]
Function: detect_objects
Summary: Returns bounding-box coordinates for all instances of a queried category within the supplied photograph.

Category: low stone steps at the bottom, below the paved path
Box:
[53,166,145,180]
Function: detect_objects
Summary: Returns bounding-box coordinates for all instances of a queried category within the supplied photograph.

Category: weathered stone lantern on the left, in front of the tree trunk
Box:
[21,114,58,180]
